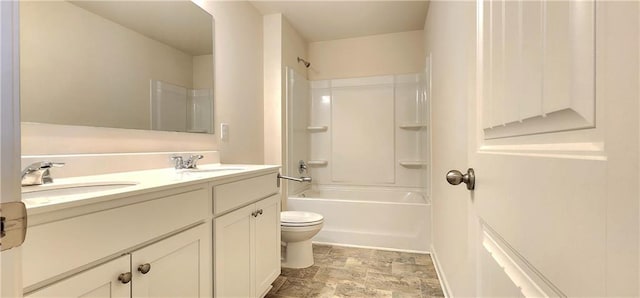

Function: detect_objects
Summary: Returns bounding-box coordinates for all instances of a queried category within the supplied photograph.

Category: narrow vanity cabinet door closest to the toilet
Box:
[254,195,280,295]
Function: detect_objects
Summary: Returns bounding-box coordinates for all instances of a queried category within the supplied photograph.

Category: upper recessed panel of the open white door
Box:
[478,1,595,139]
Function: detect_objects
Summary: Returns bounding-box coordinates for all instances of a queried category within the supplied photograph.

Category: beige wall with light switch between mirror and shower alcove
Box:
[202,1,264,164]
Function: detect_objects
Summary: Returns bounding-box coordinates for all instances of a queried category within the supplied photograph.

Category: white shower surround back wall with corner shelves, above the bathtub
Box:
[307,74,428,190]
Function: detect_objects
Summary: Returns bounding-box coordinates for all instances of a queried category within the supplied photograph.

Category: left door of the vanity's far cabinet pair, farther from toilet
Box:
[214,205,255,298]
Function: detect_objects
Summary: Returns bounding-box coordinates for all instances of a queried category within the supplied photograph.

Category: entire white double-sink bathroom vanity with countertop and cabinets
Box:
[23,165,280,297]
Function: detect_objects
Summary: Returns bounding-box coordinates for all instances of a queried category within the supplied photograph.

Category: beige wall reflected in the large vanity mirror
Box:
[20,1,193,129]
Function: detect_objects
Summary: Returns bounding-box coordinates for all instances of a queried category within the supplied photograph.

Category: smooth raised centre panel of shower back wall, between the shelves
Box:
[331,82,395,184]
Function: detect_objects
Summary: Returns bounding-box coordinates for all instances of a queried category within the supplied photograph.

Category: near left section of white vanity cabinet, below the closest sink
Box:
[23,183,212,297]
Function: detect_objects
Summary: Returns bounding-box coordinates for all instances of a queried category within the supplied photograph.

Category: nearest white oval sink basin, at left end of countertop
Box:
[22,181,138,200]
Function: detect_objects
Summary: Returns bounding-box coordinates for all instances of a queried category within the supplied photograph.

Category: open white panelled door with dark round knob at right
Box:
[472,1,640,297]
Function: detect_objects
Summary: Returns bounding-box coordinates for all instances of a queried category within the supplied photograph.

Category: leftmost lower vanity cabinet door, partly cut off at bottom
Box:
[25,255,131,298]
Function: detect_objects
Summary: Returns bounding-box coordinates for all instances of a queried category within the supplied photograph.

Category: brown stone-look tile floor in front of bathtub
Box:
[265,244,444,298]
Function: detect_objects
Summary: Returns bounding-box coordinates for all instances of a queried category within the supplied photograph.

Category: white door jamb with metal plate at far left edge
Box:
[0,1,22,297]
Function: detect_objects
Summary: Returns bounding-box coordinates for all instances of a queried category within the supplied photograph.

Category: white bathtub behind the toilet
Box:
[287,190,431,252]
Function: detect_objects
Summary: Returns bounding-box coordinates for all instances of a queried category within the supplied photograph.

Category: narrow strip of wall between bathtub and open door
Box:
[425,1,477,297]
